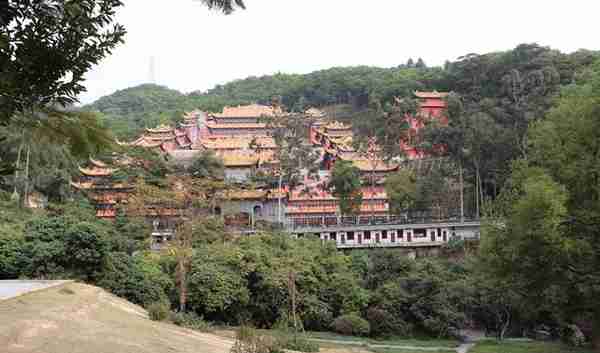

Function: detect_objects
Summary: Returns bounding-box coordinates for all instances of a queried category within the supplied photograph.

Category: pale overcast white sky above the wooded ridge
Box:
[80,0,600,103]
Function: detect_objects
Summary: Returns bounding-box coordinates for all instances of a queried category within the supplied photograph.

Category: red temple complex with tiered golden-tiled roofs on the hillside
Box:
[73,91,447,236]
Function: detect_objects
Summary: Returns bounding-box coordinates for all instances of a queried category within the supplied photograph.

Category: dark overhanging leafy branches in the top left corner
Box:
[0,0,125,124]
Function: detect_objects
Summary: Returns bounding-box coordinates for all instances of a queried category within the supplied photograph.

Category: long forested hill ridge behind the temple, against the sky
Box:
[86,44,597,138]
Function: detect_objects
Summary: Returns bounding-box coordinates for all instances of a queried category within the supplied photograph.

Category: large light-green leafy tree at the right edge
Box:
[482,64,600,347]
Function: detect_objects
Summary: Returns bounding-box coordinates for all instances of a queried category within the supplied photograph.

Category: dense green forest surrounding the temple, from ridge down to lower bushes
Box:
[0,35,600,345]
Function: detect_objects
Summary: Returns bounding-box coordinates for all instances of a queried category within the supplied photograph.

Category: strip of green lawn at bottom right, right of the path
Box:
[469,341,593,353]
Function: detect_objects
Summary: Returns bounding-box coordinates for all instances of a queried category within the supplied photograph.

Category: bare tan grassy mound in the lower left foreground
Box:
[0,283,232,353]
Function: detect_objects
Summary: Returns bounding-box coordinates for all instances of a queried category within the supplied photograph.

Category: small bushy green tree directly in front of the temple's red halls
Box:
[327,160,362,215]
